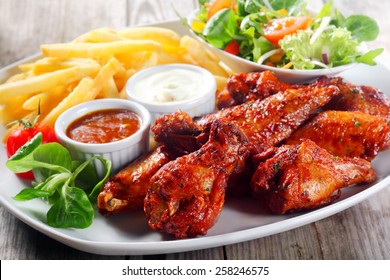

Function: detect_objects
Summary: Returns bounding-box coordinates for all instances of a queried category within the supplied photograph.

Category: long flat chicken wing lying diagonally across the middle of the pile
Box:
[197,86,339,152]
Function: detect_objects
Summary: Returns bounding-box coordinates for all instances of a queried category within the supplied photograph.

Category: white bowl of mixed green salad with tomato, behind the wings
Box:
[186,0,383,83]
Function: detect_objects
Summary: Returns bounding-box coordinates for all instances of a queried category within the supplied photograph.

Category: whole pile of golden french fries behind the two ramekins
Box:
[0,27,232,141]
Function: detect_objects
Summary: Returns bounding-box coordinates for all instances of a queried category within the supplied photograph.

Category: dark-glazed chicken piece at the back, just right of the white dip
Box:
[217,71,294,109]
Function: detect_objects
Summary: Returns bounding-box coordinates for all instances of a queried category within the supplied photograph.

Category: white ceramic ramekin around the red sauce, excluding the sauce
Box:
[54,99,150,176]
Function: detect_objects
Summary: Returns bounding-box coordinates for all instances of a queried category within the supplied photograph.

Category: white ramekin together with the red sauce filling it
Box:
[54,99,151,176]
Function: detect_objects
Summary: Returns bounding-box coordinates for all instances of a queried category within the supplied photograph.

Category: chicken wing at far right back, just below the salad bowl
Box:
[312,77,390,119]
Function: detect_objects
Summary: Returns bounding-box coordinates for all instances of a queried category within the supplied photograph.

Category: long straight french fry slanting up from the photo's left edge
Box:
[0,63,100,103]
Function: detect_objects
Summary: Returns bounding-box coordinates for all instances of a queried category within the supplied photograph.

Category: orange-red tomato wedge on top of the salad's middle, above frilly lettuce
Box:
[263,16,310,47]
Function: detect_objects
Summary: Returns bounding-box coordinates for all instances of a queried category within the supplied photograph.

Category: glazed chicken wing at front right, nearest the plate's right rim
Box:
[252,140,376,214]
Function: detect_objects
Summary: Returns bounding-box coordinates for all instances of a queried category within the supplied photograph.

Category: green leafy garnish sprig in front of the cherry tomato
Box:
[6,133,111,228]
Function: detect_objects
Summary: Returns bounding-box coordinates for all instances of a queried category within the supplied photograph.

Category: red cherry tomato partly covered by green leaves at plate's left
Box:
[6,123,59,180]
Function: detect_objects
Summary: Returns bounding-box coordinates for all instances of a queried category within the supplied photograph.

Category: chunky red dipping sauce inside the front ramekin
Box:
[65,109,141,144]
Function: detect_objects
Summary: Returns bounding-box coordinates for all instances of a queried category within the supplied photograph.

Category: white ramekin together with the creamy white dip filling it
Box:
[126,64,217,124]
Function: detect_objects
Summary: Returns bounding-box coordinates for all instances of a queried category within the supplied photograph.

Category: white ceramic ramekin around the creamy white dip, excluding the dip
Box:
[126,64,217,124]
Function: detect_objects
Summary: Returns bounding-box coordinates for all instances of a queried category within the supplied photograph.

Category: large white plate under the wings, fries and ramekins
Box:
[0,21,390,255]
